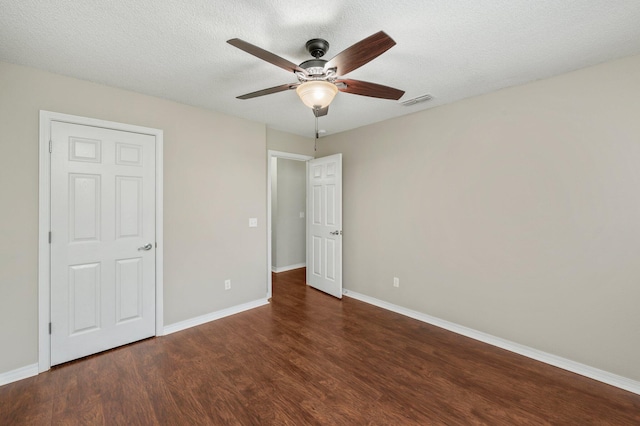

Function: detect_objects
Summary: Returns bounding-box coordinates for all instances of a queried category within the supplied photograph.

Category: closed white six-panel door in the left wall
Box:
[51,121,156,365]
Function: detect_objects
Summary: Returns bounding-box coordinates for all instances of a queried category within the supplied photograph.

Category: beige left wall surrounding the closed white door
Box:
[0,62,267,373]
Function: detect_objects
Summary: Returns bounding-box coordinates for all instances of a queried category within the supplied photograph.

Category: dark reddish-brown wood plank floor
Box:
[0,270,640,425]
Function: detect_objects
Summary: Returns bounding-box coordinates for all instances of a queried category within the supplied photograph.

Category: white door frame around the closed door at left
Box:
[38,110,164,373]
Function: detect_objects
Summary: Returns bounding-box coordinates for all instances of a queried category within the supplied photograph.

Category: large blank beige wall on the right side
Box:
[318,56,640,380]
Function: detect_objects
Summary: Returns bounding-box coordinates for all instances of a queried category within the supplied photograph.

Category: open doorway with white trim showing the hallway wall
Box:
[267,151,313,298]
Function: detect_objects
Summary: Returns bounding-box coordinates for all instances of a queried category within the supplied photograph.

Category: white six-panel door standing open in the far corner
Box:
[307,154,342,298]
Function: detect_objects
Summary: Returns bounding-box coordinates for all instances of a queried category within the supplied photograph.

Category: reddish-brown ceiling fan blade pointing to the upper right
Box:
[324,31,396,75]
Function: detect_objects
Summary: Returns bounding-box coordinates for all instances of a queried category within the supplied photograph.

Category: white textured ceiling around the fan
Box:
[0,0,640,137]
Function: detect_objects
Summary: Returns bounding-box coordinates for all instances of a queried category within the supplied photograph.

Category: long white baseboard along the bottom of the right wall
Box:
[343,289,640,395]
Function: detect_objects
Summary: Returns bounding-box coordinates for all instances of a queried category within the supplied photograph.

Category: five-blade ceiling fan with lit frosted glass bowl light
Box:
[227,31,404,117]
